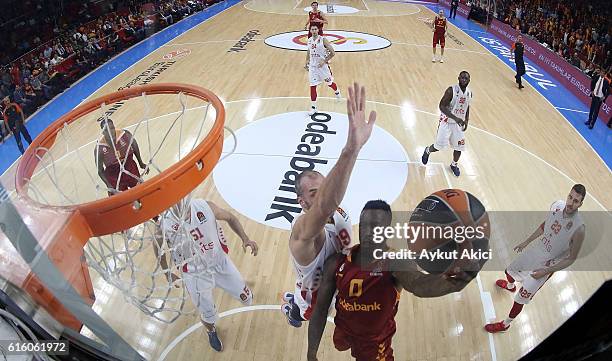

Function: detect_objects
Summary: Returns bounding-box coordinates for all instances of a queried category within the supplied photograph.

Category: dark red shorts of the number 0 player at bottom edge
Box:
[334,326,395,361]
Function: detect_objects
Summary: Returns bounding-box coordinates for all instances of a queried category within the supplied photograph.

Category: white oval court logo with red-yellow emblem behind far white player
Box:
[264,29,391,52]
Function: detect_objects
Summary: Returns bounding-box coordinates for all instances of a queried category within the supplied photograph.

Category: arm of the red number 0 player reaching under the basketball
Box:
[393,260,476,298]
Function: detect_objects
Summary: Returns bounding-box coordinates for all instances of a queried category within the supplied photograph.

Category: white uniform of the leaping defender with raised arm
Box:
[290,208,352,320]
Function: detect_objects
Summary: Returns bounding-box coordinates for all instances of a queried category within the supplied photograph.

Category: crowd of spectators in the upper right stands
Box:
[495,0,612,75]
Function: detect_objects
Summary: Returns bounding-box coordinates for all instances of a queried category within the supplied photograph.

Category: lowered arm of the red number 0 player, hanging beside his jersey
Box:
[308,254,341,361]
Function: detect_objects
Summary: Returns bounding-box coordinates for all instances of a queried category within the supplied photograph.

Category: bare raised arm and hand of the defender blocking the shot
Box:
[291,83,376,242]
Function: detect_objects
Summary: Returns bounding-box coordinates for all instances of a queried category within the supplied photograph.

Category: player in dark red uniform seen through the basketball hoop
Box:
[95,119,149,196]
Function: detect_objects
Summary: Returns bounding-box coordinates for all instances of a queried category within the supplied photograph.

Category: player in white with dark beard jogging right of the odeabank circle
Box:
[421,70,472,177]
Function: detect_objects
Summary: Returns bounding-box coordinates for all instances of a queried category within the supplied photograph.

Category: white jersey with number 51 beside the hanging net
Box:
[161,199,229,272]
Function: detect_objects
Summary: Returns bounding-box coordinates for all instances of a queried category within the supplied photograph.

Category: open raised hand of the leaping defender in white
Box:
[346,83,376,149]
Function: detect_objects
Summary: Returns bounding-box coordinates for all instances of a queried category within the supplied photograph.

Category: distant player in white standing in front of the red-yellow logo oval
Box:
[304,24,340,115]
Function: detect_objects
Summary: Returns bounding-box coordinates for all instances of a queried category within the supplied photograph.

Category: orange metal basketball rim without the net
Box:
[15,83,225,236]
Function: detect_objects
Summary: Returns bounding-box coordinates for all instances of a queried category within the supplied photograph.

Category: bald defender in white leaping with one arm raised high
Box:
[282,83,376,327]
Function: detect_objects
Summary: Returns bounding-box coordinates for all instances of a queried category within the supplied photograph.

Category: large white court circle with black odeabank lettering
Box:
[213,112,408,230]
